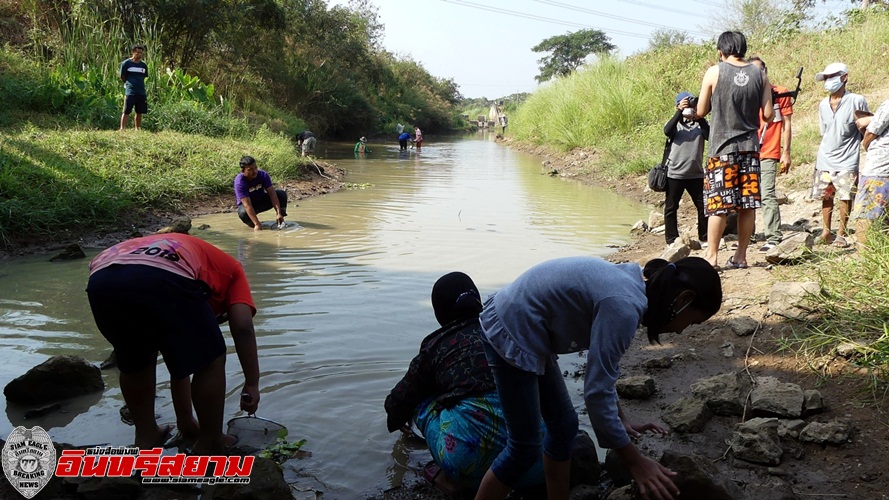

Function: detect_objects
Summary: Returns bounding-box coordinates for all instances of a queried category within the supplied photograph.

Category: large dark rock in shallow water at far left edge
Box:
[3,356,105,405]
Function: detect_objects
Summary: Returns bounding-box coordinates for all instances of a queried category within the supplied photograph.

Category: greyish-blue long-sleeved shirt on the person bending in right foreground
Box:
[480,257,648,448]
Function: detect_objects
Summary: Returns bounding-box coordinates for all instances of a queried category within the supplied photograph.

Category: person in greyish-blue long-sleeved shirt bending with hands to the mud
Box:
[475,257,722,500]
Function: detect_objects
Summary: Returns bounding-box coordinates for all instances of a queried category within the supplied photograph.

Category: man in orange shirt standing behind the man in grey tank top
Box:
[749,56,793,252]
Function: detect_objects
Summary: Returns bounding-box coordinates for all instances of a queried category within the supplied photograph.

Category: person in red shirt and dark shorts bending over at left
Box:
[86,233,259,455]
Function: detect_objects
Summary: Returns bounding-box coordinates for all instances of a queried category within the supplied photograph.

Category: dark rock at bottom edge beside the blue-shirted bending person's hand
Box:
[659,450,744,500]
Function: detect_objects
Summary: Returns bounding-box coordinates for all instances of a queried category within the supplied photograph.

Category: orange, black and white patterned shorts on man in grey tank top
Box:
[704,151,762,217]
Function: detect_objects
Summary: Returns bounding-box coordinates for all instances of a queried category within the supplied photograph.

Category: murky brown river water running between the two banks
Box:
[0,135,647,498]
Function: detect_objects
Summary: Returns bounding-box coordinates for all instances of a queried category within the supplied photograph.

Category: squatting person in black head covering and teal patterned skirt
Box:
[385,272,543,494]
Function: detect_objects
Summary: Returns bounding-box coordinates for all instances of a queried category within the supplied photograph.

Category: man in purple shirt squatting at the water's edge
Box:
[235,156,287,231]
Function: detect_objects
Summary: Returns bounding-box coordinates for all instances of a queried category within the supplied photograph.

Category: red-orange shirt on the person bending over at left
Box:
[90,233,256,314]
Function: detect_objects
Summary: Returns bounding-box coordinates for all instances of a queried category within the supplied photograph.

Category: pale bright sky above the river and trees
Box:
[327,0,849,99]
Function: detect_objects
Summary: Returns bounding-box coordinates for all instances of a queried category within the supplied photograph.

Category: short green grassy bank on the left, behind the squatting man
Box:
[0,126,305,247]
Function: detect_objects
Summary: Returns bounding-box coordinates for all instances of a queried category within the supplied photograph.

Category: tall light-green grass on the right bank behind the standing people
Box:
[509,9,889,176]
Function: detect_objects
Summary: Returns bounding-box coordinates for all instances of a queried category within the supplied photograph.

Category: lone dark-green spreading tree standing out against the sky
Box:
[531,29,616,82]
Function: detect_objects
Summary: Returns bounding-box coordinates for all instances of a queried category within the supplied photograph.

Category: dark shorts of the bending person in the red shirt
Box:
[86,264,225,379]
